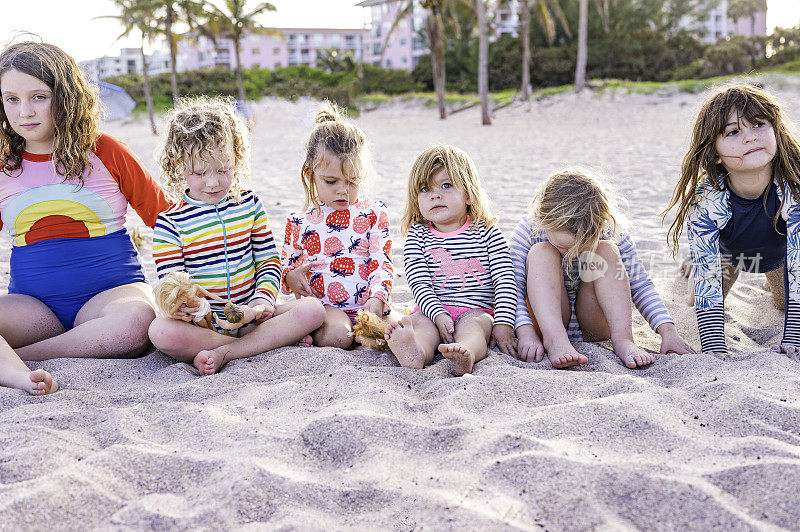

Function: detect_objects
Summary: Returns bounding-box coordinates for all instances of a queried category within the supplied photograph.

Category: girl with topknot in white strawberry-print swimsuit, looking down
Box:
[281,105,394,349]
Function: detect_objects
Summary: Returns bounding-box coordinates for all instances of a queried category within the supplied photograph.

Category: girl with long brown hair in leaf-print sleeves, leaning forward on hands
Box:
[668,83,800,354]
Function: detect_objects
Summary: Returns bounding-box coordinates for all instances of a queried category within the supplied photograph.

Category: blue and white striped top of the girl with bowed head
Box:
[511,215,675,342]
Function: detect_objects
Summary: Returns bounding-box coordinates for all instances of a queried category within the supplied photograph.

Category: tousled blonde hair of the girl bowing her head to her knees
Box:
[531,168,625,264]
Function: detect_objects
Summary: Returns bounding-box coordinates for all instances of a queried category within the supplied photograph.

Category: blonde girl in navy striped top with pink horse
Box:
[386,146,516,376]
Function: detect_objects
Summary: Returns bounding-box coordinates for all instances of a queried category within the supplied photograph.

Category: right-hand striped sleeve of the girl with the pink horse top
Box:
[485,227,517,328]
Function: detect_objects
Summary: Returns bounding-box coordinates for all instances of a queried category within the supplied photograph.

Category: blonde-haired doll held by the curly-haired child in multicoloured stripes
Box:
[154,272,256,331]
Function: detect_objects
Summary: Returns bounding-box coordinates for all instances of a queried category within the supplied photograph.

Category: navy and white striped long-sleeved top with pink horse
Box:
[403,220,516,327]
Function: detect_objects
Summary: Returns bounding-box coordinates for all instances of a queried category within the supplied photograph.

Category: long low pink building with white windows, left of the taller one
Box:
[176,28,367,72]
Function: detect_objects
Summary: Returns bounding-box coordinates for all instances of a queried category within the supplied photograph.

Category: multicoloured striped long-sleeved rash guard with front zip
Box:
[153,191,281,317]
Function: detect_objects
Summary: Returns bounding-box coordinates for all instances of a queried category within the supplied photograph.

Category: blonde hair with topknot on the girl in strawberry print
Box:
[300,101,372,209]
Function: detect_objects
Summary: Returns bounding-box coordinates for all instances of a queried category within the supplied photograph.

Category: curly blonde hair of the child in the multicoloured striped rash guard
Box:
[157,96,250,201]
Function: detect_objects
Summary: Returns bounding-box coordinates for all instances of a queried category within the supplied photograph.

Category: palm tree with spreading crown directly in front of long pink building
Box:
[198,0,281,102]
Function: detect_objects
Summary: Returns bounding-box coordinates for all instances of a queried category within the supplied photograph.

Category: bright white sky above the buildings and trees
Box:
[0,0,800,61]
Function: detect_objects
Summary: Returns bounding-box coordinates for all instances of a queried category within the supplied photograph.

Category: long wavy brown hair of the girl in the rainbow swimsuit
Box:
[0,42,100,186]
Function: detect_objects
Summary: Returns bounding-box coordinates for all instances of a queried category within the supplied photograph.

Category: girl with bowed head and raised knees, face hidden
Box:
[511,170,694,368]
